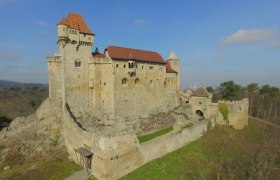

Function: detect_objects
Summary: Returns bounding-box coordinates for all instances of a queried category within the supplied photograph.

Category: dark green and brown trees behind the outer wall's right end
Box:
[206,81,280,125]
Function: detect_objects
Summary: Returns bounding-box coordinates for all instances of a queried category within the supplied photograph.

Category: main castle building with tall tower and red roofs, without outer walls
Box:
[47,13,180,119]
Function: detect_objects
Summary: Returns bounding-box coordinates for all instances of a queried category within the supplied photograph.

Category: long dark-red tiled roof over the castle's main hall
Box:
[105,46,165,63]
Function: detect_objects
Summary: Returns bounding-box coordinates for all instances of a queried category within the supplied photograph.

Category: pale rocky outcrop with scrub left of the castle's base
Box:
[0,99,64,165]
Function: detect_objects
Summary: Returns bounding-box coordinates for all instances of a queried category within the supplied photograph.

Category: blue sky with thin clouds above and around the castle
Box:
[0,0,280,88]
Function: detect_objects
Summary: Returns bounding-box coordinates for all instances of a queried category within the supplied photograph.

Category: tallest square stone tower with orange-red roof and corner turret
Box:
[57,13,95,111]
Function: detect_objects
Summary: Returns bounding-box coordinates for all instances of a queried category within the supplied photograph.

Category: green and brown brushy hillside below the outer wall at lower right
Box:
[122,119,280,180]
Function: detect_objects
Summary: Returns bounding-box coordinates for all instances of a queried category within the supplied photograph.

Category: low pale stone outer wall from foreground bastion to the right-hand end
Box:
[60,99,248,179]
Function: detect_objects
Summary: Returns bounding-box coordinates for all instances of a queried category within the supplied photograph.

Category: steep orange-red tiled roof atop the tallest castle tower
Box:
[58,13,94,35]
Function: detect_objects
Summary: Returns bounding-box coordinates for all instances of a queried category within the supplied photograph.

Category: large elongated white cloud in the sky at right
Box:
[221,29,279,46]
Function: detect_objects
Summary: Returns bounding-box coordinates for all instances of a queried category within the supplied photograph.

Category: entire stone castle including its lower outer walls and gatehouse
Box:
[44,13,248,179]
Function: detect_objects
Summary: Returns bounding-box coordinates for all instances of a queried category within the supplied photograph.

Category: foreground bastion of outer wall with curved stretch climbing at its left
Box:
[63,104,144,179]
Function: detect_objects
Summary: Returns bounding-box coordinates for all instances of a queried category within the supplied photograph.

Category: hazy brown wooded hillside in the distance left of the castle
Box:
[0,80,48,130]
